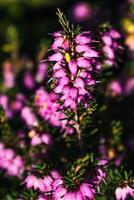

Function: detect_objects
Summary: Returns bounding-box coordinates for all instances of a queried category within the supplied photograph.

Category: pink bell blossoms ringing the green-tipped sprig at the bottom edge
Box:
[23,161,106,200]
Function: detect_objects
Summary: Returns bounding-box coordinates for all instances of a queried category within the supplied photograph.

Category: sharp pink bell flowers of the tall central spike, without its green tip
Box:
[48,32,100,110]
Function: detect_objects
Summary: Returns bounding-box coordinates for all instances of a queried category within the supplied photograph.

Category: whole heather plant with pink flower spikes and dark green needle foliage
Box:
[0,4,134,200]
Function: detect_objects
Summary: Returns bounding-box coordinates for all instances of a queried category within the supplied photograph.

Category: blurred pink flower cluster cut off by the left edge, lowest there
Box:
[0,142,24,177]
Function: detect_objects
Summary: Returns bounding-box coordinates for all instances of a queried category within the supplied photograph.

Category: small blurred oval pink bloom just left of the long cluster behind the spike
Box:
[21,107,38,126]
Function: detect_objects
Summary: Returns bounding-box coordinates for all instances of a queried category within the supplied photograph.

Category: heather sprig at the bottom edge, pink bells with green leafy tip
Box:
[20,155,106,200]
